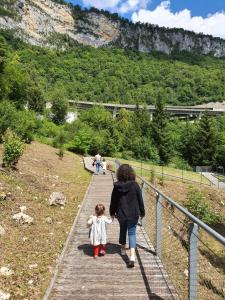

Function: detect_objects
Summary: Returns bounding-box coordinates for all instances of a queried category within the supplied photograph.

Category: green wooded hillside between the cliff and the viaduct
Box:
[0,32,225,105]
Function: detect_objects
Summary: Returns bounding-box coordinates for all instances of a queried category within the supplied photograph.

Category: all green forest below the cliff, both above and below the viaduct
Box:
[0,33,225,168]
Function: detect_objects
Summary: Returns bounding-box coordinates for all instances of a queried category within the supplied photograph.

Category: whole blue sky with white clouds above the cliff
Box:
[67,0,225,39]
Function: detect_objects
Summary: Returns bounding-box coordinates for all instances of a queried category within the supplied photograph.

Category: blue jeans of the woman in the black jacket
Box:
[119,220,138,248]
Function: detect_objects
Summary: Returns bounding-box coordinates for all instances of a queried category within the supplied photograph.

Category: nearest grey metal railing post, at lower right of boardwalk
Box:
[188,223,198,300]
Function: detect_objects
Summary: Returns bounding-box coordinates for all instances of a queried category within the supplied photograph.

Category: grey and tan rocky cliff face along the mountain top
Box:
[0,0,225,57]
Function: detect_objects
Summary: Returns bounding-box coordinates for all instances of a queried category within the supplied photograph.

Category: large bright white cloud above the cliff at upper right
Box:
[132,1,225,38]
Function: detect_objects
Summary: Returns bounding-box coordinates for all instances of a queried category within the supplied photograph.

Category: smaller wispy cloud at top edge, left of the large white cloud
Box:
[83,0,151,14]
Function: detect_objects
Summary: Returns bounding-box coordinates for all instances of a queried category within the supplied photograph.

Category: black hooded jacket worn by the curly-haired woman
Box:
[109,181,145,221]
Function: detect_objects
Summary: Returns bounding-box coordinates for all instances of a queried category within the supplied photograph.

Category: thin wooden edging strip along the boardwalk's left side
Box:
[43,175,93,300]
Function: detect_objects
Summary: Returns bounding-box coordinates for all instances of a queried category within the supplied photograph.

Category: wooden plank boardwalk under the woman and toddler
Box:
[44,159,179,300]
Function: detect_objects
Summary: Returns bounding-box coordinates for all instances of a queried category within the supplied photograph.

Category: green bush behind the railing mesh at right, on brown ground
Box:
[185,188,223,225]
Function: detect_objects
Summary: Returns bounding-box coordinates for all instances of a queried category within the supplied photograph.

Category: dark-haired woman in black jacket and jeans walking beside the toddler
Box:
[110,164,145,268]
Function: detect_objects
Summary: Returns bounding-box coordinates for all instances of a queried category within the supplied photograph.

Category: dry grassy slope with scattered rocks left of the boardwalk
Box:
[0,142,90,300]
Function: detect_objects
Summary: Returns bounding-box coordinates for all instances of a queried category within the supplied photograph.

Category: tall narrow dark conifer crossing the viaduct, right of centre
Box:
[151,94,172,163]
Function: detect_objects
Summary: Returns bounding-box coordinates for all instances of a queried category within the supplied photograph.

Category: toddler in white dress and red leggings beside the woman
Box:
[87,204,112,258]
